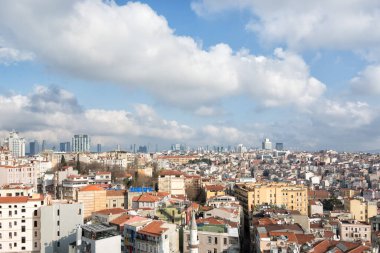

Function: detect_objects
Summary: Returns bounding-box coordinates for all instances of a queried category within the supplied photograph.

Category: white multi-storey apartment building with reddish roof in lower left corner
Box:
[0,195,44,253]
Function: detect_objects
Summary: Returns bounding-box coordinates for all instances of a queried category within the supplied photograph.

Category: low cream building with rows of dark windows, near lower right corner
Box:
[338,220,371,241]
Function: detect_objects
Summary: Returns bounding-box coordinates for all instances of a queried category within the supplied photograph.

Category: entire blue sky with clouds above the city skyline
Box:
[0,0,380,151]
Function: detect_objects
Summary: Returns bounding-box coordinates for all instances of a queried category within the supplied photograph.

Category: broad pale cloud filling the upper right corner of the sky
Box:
[192,0,380,53]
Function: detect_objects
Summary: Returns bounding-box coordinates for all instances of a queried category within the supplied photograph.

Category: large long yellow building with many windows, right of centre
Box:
[234,182,308,215]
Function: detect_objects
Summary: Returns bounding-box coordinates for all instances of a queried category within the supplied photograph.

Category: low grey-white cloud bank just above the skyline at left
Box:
[0,86,195,145]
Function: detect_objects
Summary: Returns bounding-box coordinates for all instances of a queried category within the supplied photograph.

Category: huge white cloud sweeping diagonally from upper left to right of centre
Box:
[0,0,325,109]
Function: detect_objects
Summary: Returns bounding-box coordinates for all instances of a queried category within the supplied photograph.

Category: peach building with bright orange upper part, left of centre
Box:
[76,185,107,219]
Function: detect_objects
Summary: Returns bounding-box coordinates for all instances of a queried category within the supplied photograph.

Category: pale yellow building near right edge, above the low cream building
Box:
[344,198,377,222]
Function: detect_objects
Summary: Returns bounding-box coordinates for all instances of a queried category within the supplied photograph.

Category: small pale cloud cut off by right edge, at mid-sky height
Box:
[351,65,380,96]
